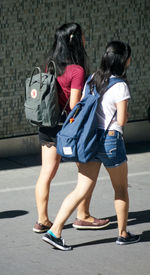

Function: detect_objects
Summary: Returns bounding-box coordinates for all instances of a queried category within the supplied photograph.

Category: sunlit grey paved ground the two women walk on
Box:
[0,143,150,275]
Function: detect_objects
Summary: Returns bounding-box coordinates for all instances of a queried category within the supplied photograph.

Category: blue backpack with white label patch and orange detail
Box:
[57,76,123,163]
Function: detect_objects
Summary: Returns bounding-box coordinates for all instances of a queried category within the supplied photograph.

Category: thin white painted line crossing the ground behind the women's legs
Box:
[0,171,150,193]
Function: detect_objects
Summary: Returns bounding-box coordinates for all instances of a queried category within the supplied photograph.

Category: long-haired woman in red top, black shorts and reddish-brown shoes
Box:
[33,23,109,233]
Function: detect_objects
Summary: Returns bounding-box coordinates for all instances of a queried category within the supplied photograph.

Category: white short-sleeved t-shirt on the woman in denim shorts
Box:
[96,76,130,133]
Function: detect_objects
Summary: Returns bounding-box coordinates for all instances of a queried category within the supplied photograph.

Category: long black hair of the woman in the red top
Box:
[48,23,88,75]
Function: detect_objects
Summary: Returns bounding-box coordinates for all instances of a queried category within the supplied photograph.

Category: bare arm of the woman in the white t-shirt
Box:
[116,100,128,126]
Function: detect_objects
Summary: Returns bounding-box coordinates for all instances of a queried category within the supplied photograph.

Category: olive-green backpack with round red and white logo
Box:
[24,61,60,127]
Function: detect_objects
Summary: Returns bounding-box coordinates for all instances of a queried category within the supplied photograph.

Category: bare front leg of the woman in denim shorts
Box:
[107,162,129,237]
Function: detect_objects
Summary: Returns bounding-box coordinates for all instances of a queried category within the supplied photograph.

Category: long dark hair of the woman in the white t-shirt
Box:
[90,41,131,94]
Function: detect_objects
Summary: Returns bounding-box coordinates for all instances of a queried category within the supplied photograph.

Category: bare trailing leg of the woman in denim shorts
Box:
[51,162,100,237]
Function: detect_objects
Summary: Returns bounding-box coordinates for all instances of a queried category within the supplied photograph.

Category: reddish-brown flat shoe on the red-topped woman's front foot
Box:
[72,218,110,229]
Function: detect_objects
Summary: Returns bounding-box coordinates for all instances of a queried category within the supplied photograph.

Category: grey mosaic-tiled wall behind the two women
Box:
[0,0,150,138]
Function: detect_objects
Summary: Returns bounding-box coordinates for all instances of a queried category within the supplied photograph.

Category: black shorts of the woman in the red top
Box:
[39,125,62,145]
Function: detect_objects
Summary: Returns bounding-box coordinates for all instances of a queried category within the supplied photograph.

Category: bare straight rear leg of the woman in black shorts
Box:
[35,145,61,226]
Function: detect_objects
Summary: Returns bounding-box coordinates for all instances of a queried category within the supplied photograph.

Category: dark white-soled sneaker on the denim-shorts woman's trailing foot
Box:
[42,233,72,251]
